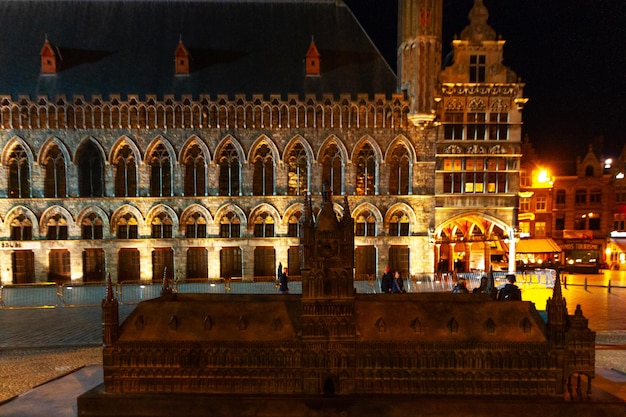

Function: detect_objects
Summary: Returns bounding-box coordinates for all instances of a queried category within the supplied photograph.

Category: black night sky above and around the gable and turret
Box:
[345,0,626,168]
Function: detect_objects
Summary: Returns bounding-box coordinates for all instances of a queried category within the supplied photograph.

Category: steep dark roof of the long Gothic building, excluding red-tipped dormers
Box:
[0,0,396,99]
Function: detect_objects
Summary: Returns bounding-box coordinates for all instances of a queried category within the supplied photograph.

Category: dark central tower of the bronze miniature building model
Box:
[300,186,356,395]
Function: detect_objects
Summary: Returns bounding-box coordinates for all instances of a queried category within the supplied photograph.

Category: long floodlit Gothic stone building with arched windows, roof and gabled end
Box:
[0,0,525,284]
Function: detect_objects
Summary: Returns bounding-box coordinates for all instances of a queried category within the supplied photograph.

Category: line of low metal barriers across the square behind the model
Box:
[0,269,626,309]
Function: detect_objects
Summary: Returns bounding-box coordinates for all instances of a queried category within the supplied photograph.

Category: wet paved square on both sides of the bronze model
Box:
[0,277,626,417]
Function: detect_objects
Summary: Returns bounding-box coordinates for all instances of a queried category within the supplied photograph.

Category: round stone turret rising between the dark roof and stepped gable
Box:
[398,0,443,126]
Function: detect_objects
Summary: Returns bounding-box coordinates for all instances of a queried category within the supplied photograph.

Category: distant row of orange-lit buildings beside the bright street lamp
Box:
[516,142,626,272]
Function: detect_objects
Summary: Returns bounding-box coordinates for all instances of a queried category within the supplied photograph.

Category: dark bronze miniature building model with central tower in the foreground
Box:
[78,191,604,416]
